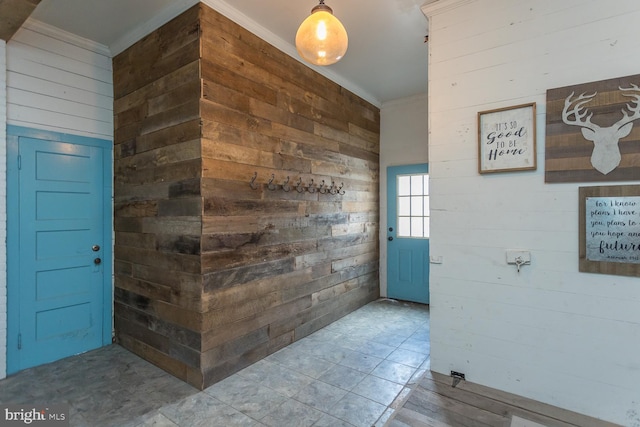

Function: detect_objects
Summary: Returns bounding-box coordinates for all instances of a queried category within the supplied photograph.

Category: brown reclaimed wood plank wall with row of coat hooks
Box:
[114,4,380,387]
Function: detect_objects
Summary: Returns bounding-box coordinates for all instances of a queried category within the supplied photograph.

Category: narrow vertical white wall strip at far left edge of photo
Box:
[0,40,7,379]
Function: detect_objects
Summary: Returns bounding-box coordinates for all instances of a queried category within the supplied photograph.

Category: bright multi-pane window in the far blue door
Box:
[397,174,429,239]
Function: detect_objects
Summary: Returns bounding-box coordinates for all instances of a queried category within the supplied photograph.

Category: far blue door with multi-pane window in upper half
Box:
[387,164,429,304]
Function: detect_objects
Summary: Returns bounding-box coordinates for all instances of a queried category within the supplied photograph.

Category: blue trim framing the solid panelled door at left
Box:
[7,125,113,374]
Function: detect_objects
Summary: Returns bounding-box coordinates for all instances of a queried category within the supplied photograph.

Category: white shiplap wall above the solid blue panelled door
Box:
[0,20,113,378]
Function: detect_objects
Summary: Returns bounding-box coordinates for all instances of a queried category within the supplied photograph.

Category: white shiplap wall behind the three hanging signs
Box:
[423,0,640,427]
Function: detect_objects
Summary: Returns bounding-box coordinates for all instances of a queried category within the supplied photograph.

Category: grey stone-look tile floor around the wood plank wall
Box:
[0,299,429,427]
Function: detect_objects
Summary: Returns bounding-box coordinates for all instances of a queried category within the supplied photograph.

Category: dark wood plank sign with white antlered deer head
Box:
[545,75,640,183]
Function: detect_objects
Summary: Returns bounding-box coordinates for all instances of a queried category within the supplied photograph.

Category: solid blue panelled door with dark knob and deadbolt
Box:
[7,128,111,373]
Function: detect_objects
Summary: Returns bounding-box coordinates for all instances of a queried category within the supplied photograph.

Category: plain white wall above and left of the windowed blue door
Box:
[380,95,429,296]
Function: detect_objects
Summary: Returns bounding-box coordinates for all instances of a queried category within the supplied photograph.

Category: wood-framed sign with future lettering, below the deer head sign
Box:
[579,185,640,276]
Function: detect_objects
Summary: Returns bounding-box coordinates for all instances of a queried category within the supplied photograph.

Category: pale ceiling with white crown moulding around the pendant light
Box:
[31,0,428,106]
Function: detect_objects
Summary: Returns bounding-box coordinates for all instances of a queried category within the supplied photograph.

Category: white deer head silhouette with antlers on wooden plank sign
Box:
[562,84,640,175]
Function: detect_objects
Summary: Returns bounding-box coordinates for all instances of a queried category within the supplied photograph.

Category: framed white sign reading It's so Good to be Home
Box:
[478,102,536,173]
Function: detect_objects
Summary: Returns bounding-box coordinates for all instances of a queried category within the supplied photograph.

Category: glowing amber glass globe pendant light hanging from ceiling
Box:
[296,0,349,65]
